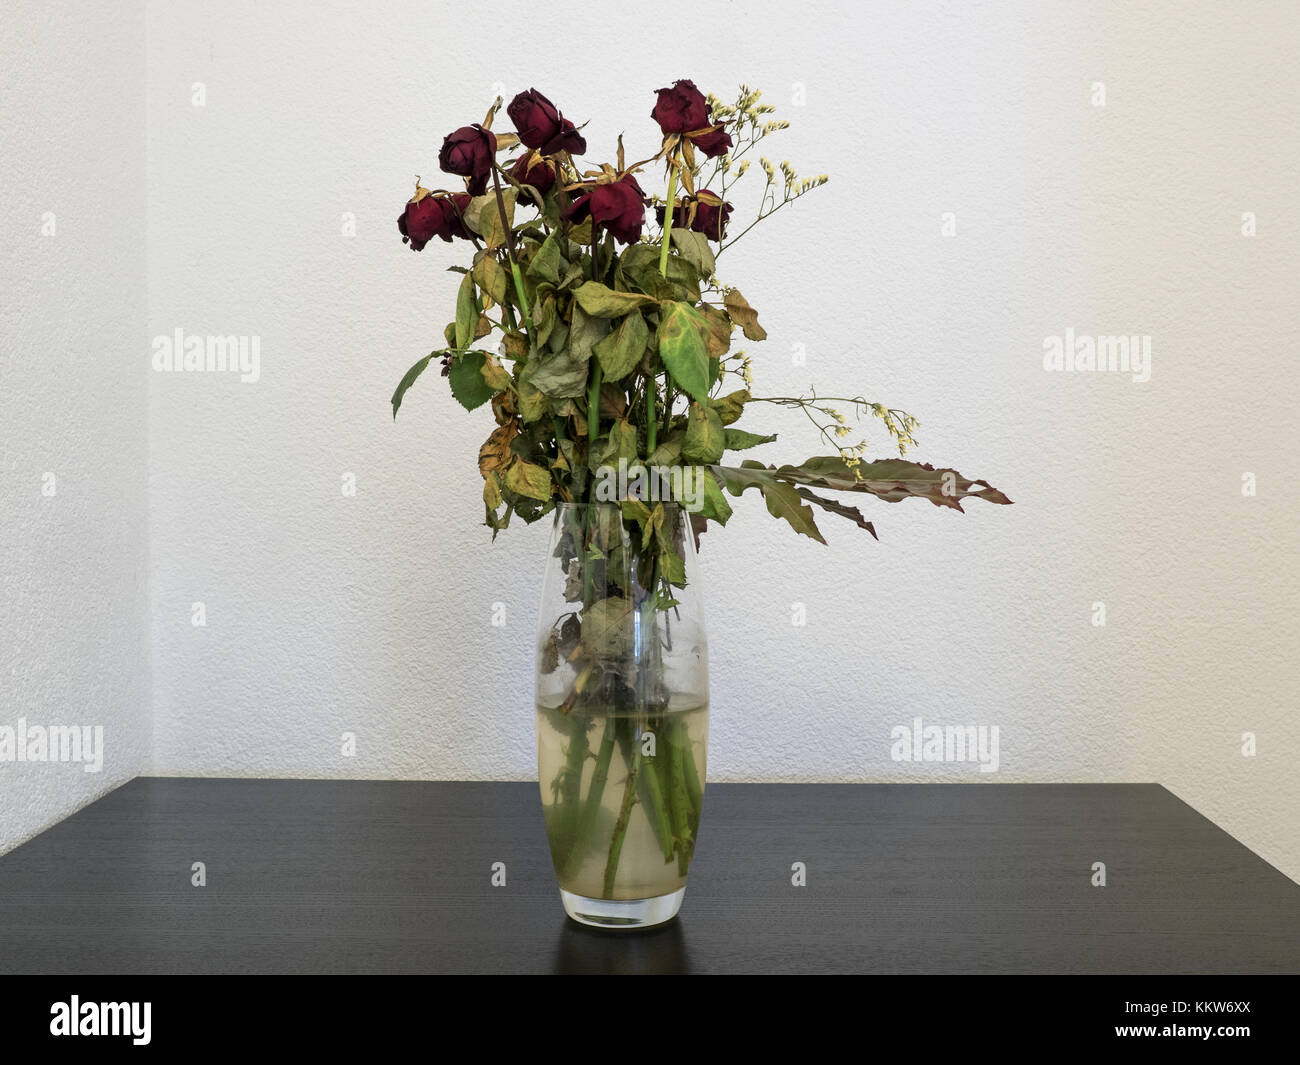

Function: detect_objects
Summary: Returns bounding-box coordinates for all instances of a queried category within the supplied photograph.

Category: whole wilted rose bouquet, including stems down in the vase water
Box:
[393,81,1010,919]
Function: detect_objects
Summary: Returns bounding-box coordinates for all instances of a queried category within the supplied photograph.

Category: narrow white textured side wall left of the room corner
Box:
[0,0,150,852]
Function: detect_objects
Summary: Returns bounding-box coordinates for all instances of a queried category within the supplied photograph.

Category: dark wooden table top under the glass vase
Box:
[0,779,1300,974]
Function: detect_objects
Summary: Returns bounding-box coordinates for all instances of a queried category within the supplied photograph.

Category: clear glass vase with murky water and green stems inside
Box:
[536,503,709,928]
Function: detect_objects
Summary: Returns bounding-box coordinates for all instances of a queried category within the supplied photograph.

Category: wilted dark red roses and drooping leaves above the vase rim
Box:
[393,81,1009,542]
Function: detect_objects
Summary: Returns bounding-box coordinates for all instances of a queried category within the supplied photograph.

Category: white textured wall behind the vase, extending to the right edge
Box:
[10,3,1300,876]
